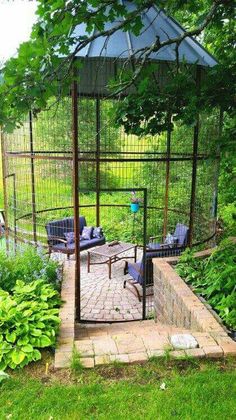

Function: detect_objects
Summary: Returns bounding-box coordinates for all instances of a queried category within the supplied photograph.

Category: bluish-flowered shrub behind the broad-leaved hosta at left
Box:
[0,247,59,292]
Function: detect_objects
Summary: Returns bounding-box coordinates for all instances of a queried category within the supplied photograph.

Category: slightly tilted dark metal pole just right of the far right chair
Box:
[188,66,201,246]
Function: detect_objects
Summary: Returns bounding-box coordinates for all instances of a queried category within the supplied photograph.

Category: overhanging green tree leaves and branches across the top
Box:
[0,0,234,129]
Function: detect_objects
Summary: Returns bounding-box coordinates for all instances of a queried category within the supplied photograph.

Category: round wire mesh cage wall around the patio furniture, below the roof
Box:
[0,57,218,322]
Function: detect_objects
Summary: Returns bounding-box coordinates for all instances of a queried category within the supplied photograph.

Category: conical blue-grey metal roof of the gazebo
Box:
[74,1,217,67]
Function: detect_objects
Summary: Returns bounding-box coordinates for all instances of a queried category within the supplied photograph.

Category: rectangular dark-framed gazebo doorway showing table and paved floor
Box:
[80,189,148,322]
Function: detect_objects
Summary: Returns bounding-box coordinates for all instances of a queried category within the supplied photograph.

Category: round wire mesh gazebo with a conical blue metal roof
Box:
[2,1,220,321]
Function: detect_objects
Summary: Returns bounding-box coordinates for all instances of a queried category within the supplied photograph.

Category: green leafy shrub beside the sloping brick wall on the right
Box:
[176,240,236,329]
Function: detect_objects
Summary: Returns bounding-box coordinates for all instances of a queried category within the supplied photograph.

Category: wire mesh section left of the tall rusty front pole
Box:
[1,98,73,253]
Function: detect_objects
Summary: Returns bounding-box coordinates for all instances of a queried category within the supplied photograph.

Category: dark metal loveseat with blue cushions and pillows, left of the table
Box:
[45,216,106,259]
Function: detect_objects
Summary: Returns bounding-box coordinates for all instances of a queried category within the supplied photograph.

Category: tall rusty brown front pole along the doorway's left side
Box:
[71,71,80,321]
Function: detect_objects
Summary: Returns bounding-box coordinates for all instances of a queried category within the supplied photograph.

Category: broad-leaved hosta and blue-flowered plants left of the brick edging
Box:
[0,247,61,370]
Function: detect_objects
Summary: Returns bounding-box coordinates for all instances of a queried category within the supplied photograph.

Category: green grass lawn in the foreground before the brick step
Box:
[0,356,236,420]
